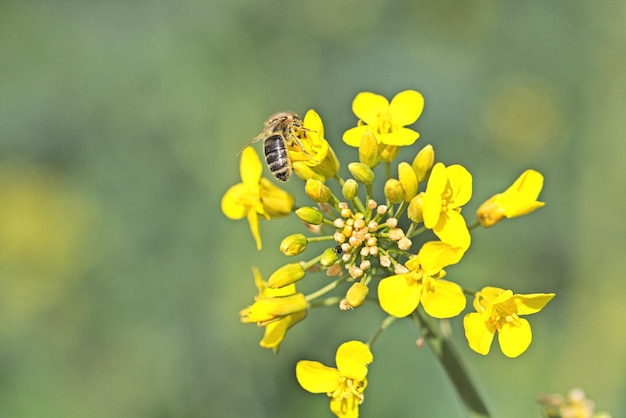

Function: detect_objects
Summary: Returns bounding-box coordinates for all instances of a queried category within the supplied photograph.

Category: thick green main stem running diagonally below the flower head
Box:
[411,308,490,418]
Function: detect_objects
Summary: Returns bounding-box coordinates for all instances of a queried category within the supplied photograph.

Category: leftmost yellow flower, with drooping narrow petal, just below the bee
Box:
[222,147,294,250]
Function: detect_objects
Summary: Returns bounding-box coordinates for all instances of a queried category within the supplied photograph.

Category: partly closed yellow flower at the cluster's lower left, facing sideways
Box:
[239,267,306,353]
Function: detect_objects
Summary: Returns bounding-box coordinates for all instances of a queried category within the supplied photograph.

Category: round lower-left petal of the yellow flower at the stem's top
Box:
[378,274,422,318]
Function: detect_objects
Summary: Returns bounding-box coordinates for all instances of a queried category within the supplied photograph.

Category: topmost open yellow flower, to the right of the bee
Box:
[343,90,424,147]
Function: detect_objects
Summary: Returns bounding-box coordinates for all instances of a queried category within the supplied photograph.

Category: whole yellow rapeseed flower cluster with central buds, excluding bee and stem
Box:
[222,90,554,417]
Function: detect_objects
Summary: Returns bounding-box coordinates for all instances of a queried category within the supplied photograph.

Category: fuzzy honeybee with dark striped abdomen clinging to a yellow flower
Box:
[244,112,306,182]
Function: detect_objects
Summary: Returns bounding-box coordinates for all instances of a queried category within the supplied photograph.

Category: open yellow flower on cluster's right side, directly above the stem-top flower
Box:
[422,163,472,249]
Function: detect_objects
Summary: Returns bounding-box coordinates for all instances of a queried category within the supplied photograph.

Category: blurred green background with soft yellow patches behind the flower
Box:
[0,0,626,417]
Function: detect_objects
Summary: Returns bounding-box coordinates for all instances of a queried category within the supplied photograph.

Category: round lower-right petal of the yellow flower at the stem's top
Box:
[421,279,467,318]
